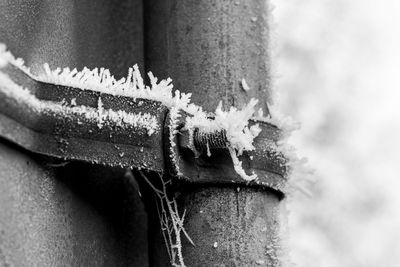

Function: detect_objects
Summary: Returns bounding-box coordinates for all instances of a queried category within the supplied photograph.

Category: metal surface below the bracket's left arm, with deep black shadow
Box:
[0,140,148,267]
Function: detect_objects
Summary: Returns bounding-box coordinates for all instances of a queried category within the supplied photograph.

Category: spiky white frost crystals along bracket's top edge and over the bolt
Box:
[0,44,268,181]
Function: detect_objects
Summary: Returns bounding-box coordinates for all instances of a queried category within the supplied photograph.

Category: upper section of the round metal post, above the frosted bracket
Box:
[144,0,271,112]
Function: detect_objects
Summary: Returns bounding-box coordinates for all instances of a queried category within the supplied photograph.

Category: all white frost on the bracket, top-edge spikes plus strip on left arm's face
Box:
[0,45,268,181]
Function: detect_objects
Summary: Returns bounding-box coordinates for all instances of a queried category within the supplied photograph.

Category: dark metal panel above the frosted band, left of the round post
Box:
[0,0,144,77]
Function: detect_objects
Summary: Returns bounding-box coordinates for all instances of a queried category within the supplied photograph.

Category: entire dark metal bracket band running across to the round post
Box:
[0,65,286,192]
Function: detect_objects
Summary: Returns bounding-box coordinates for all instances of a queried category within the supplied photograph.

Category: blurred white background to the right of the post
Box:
[272,0,400,267]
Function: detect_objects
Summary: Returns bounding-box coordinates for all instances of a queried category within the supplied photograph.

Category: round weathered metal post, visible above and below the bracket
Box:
[144,0,282,266]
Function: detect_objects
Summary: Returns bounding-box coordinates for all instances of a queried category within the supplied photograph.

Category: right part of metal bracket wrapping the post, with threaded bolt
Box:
[166,111,287,193]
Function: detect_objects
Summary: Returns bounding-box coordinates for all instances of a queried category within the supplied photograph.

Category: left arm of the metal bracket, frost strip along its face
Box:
[0,65,168,172]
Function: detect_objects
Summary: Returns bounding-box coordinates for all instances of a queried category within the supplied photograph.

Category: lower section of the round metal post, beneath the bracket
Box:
[179,186,280,266]
